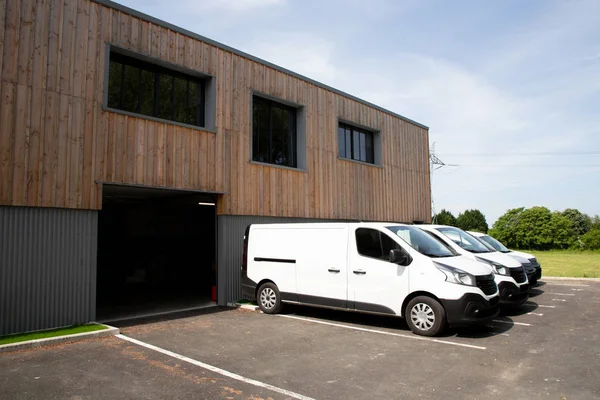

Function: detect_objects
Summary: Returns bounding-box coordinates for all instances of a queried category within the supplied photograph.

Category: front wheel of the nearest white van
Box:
[405,296,446,336]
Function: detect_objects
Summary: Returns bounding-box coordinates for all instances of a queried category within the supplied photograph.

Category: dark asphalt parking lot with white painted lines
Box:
[0,280,600,400]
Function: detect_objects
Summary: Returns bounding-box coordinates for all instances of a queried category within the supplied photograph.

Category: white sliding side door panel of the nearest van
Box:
[294,226,348,308]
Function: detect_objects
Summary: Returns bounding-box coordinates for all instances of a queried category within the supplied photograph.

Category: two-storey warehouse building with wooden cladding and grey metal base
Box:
[0,0,430,335]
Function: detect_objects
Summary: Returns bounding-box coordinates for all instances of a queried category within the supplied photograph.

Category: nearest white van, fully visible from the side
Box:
[241,222,499,336]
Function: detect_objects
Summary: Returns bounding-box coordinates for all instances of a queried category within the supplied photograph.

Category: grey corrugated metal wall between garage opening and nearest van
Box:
[217,215,342,305]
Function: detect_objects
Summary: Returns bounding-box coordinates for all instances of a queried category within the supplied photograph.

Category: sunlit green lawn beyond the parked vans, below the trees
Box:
[523,250,600,279]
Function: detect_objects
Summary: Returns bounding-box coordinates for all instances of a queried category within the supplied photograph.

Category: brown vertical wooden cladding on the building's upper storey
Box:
[0,0,430,221]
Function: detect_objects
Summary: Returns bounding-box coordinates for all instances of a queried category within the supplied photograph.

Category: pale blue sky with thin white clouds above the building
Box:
[118,0,600,226]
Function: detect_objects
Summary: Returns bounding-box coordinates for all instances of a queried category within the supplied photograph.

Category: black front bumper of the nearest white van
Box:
[442,293,500,326]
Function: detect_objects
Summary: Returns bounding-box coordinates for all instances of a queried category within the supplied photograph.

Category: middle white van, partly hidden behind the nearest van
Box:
[418,225,530,306]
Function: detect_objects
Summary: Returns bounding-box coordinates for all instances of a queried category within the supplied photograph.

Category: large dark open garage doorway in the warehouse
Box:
[96,185,217,321]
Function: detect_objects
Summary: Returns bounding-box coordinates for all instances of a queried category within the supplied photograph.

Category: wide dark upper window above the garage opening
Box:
[107,52,205,127]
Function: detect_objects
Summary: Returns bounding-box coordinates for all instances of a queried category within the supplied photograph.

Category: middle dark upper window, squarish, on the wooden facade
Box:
[252,96,298,168]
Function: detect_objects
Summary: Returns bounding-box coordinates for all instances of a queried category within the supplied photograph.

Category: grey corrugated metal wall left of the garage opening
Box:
[0,207,98,335]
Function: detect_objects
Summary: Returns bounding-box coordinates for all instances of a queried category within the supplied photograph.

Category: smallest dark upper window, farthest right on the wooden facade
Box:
[338,123,375,164]
